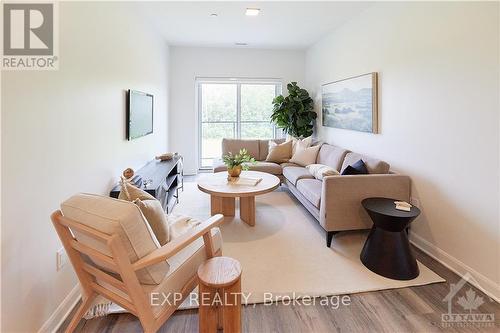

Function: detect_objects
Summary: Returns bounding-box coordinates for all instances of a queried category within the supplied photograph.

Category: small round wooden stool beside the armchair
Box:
[198,257,241,333]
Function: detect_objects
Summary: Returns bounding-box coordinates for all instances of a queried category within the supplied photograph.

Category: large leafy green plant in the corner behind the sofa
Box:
[271,82,317,138]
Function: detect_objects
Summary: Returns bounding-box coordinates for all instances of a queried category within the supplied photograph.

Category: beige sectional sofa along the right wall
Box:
[214,139,410,247]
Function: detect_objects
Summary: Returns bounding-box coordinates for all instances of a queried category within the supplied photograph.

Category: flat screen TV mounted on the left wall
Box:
[127,90,153,140]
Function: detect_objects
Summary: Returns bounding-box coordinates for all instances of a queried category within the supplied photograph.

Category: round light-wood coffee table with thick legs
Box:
[198,171,280,226]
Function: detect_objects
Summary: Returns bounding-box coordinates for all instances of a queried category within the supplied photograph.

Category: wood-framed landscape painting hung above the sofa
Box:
[321,73,378,133]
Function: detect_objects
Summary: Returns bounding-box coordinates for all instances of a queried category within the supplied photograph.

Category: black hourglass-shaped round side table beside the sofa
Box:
[360,198,420,280]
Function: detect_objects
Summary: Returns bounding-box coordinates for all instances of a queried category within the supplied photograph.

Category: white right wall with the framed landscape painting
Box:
[305,2,500,298]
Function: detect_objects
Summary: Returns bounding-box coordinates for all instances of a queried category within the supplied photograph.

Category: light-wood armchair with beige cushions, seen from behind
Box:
[51,194,223,333]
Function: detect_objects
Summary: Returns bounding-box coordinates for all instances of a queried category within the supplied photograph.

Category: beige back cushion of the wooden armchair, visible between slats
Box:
[61,194,169,285]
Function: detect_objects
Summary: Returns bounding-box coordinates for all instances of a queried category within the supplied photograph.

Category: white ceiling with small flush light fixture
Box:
[138,1,370,49]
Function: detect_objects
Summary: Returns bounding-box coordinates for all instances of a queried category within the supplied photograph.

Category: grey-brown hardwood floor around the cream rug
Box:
[59,244,500,333]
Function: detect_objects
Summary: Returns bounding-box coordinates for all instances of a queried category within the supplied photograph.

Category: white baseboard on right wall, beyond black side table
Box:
[410,232,500,303]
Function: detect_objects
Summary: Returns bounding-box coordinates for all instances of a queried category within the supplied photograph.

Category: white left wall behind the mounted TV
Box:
[1,2,168,332]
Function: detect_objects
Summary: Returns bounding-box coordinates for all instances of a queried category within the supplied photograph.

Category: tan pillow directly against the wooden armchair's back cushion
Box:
[133,199,170,245]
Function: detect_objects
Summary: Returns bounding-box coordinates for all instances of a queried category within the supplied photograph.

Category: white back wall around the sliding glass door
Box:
[169,46,305,174]
